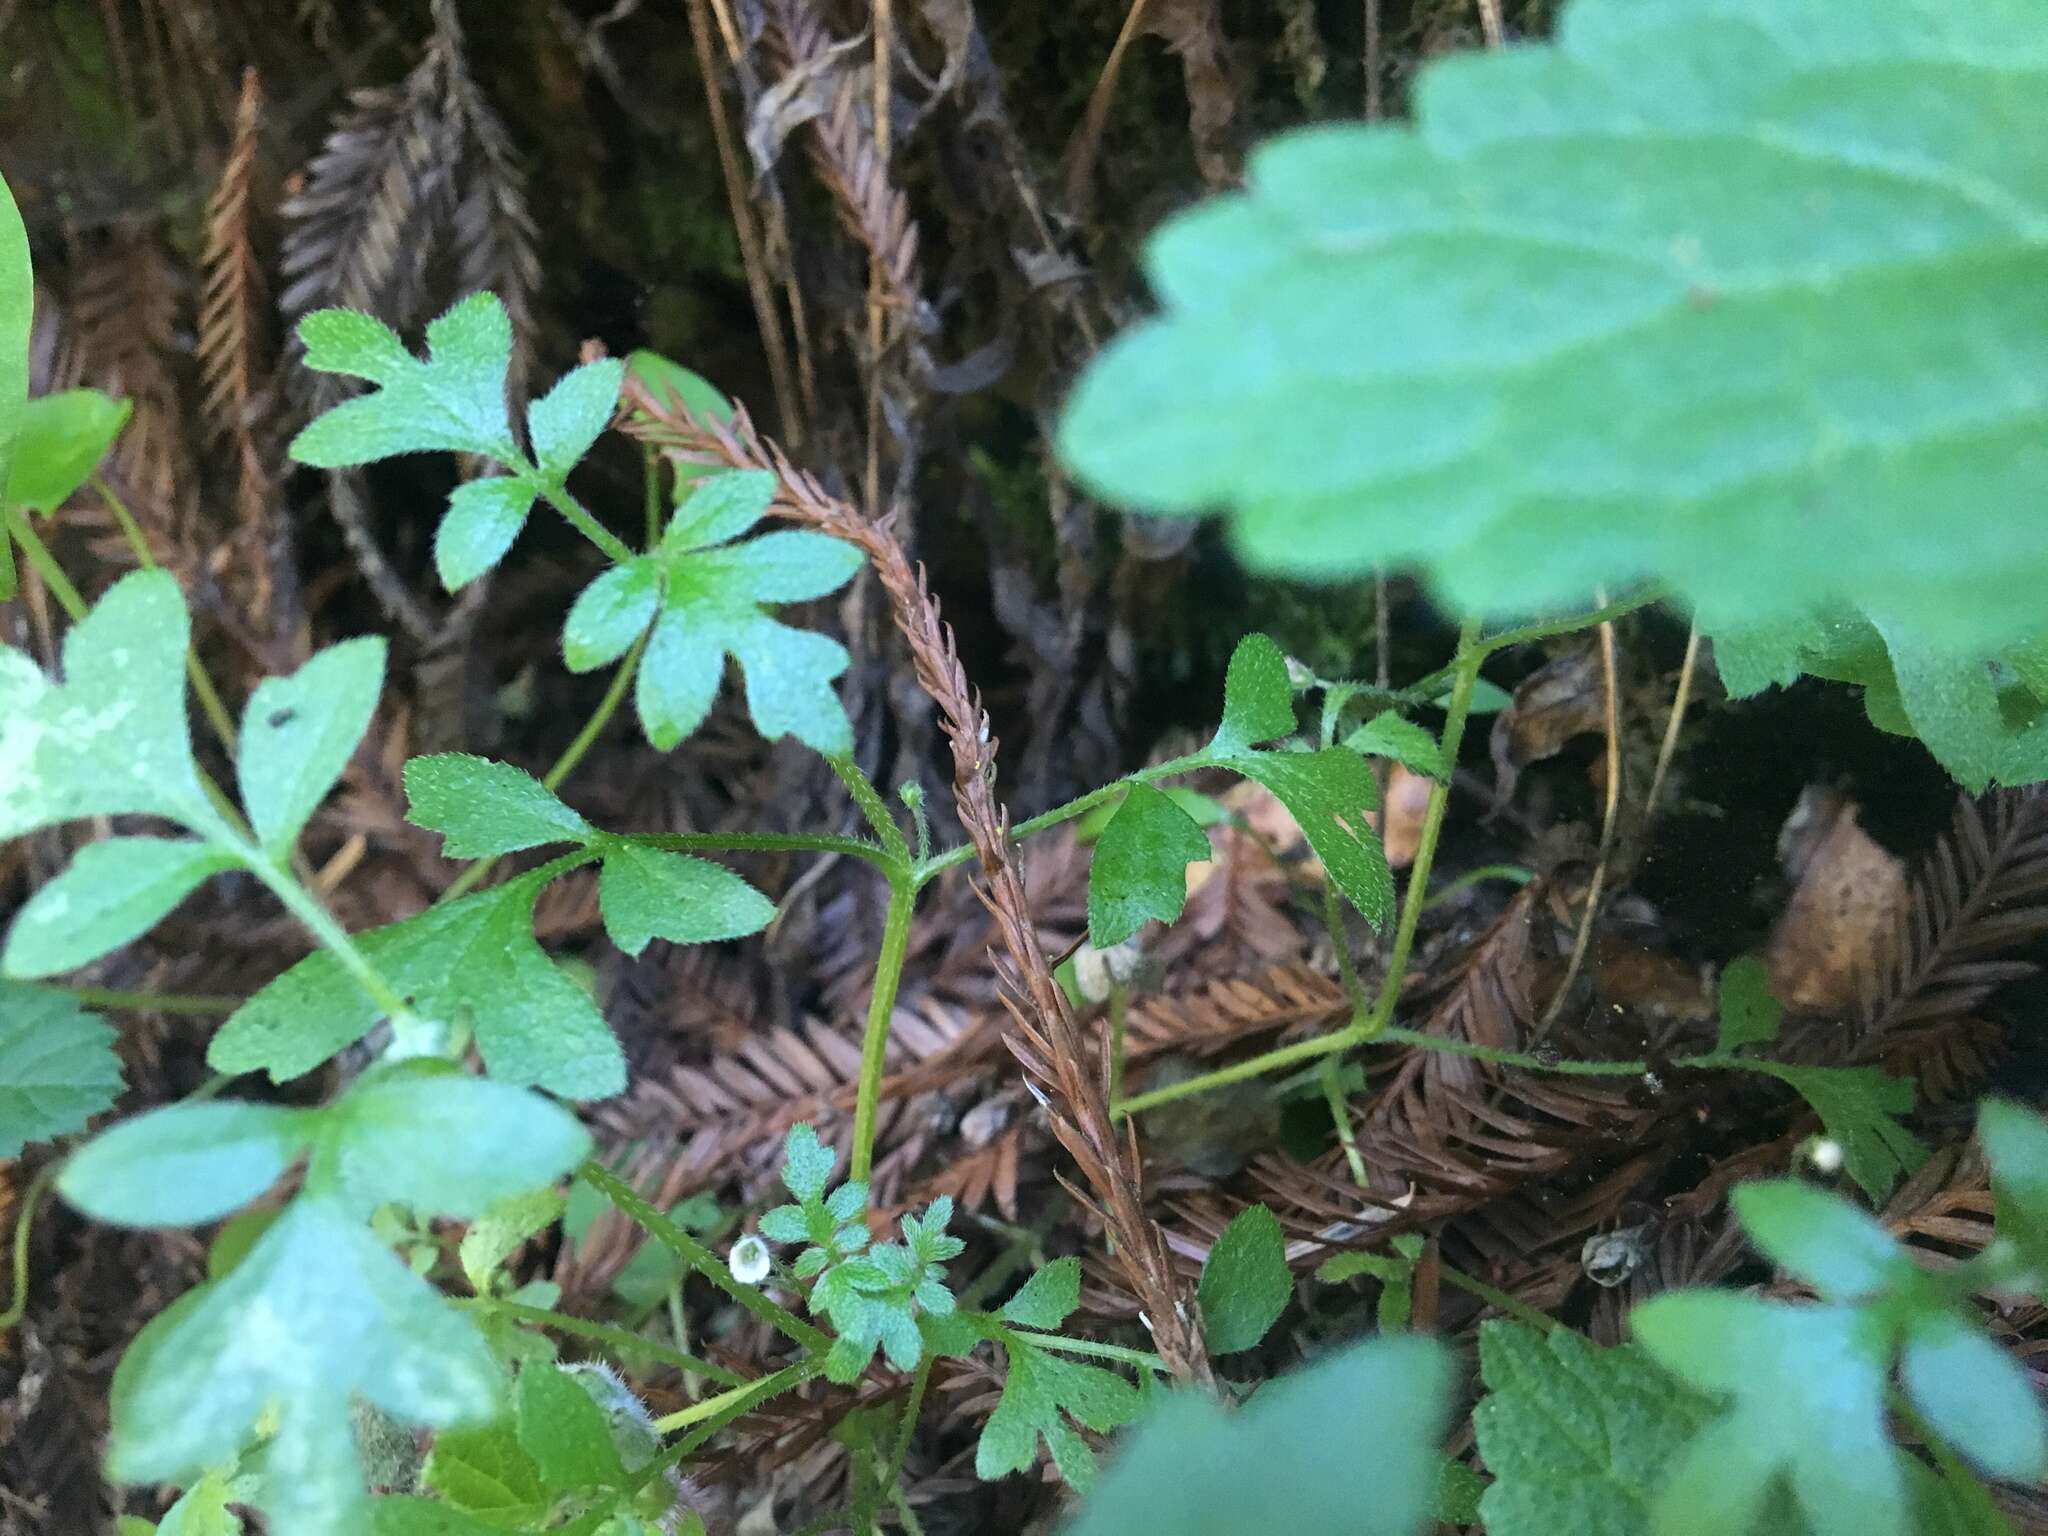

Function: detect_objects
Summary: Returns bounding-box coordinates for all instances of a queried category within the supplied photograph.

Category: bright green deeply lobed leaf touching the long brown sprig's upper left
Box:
[635,469,862,756]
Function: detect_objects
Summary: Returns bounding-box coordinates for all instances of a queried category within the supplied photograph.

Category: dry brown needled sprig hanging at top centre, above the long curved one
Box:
[750,0,920,317]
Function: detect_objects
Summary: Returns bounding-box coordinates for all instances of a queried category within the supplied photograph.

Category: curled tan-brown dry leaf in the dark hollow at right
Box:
[1765,786,1907,1014]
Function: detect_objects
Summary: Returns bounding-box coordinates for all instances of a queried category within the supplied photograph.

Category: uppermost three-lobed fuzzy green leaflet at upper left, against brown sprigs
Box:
[289,293,518,469]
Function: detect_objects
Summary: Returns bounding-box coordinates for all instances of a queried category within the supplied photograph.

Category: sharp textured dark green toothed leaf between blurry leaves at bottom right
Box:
[1473,1321,1714,1536]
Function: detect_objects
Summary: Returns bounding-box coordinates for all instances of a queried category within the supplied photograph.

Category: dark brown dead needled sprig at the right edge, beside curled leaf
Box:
[1855,786,2048,1057]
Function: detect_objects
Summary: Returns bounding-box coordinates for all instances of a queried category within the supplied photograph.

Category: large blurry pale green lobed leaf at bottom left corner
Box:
[106,1196,504,1536]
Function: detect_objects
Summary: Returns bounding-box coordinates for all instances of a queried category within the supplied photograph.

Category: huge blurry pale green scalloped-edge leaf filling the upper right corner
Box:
[1061,0,2048,645]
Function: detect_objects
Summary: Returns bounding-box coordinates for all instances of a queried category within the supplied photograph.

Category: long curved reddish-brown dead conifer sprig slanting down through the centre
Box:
[627,381,1212,1384]
